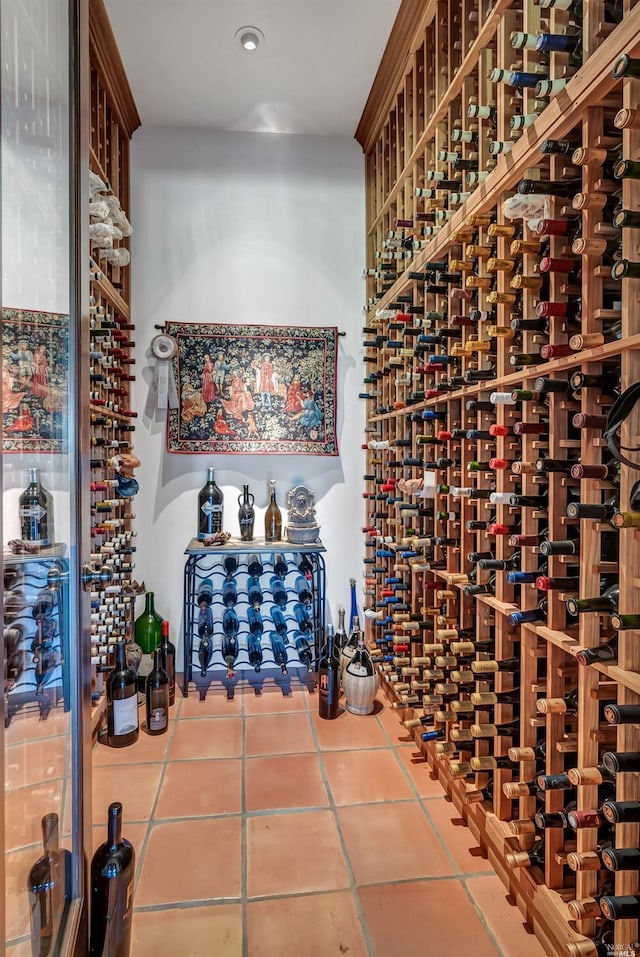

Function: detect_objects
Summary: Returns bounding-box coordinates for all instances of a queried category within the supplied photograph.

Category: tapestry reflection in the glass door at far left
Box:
[2,309,69,452]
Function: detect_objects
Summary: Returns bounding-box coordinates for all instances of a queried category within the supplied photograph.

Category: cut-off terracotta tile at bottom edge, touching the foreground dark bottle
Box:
[131,904,242,957]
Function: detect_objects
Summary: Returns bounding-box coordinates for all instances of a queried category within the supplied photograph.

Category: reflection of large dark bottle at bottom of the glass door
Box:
[27,814,68,957]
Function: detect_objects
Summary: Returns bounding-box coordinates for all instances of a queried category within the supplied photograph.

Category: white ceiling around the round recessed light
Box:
[106,0,400,136]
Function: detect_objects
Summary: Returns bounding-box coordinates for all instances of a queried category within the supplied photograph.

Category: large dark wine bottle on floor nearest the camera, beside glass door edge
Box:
[89,801,135,957]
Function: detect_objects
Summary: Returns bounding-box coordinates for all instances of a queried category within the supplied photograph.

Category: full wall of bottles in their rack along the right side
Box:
[362,0,640,955]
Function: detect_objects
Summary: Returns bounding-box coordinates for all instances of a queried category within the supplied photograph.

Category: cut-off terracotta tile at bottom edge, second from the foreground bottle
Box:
[247,892,367,957]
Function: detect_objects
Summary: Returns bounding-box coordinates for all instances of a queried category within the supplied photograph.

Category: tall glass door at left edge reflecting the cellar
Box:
[0,0,90,957]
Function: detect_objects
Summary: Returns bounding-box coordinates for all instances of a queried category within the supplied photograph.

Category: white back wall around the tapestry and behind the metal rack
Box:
[131,127,365,656]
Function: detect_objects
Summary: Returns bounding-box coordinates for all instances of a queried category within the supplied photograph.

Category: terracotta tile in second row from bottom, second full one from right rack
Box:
[247,811,349,897]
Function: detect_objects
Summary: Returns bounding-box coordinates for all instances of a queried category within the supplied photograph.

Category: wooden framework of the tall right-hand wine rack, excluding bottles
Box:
[356,0,640,955]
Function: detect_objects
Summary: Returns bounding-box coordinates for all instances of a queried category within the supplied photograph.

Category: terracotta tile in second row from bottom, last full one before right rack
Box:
[338,802,454,880]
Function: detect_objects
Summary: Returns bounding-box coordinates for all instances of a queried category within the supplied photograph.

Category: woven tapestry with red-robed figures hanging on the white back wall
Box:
[166,322,338,455]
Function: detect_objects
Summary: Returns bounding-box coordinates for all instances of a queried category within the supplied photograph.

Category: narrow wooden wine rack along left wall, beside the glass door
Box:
[89,0,140,712]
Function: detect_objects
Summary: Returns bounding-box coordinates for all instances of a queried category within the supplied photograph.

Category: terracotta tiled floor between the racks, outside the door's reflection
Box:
[93,681,544,957]
